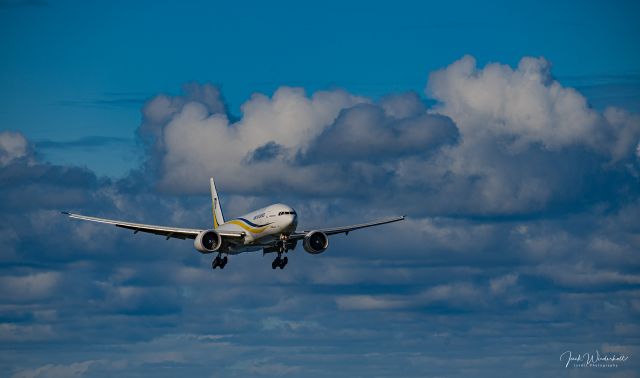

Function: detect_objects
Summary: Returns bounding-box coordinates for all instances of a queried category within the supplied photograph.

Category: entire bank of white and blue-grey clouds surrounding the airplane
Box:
[0,57,640,377]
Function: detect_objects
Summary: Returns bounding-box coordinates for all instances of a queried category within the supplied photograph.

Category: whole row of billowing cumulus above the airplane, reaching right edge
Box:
[131,56,640,216]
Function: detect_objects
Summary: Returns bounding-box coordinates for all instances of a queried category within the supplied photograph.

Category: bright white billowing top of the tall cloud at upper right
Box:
[427,56,640,158]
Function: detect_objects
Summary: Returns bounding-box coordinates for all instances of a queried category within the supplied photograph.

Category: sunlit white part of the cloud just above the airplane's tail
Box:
[160,87,364,192]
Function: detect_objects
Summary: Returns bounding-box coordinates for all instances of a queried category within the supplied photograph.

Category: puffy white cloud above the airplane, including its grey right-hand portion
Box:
[140,87,457,199]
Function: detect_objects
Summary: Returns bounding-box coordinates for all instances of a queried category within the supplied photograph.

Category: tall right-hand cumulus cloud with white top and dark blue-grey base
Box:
[398,56,640,215]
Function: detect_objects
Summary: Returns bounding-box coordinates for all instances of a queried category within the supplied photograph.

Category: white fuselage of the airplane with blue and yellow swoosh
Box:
[216,203,298,254]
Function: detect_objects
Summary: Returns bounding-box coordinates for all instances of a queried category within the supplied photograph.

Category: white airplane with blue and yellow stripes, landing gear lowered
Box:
[62,178,405,269]
